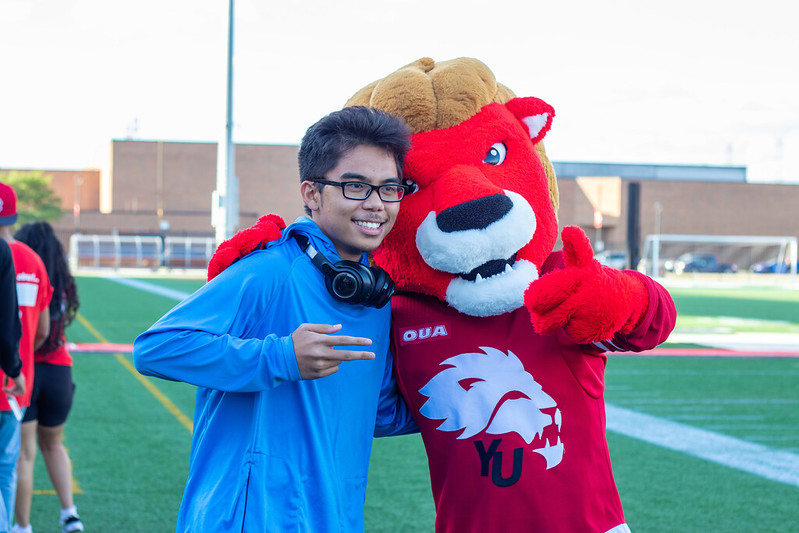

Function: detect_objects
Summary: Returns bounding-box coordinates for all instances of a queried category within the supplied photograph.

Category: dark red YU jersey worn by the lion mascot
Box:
[391,262,676,533]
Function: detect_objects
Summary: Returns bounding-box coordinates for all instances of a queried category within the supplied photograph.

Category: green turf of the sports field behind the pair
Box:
[21,276,799,533]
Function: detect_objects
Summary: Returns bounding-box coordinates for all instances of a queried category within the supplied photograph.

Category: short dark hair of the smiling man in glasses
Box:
[297,106,411,215]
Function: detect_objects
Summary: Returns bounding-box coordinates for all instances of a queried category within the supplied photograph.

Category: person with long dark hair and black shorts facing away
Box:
[12,222,83,533]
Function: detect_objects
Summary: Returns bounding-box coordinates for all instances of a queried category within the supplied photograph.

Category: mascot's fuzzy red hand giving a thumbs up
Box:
[524,226,649,344]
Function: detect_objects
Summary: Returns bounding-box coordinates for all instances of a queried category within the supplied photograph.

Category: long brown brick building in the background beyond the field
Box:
[1,140,799,268]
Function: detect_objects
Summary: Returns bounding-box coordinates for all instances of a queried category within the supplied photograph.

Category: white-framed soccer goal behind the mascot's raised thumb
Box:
[638,234,799,283]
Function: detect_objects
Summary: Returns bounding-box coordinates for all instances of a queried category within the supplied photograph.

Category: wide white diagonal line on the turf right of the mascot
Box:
[606,404,799,487]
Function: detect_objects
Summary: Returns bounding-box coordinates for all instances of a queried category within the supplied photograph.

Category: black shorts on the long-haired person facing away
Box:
[22,363,75,427]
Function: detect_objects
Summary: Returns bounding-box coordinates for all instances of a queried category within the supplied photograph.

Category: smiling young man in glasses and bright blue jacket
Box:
[133,107,416,532]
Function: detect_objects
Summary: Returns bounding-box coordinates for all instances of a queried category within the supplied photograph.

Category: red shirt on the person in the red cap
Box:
[6,241,53,411]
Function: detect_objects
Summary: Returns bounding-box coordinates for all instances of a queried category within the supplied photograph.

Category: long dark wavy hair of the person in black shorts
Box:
[14,222,80,353]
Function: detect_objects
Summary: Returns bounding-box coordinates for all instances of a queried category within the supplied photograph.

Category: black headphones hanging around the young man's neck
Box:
[292,233,394,309]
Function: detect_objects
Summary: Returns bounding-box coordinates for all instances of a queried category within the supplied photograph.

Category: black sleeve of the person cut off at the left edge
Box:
[0,242,22,378]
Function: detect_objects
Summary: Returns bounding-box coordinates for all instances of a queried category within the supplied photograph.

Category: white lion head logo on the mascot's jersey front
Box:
[419,346,563,469]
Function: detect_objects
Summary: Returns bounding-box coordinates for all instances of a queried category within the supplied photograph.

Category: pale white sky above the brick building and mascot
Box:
[0,0,799,183]
